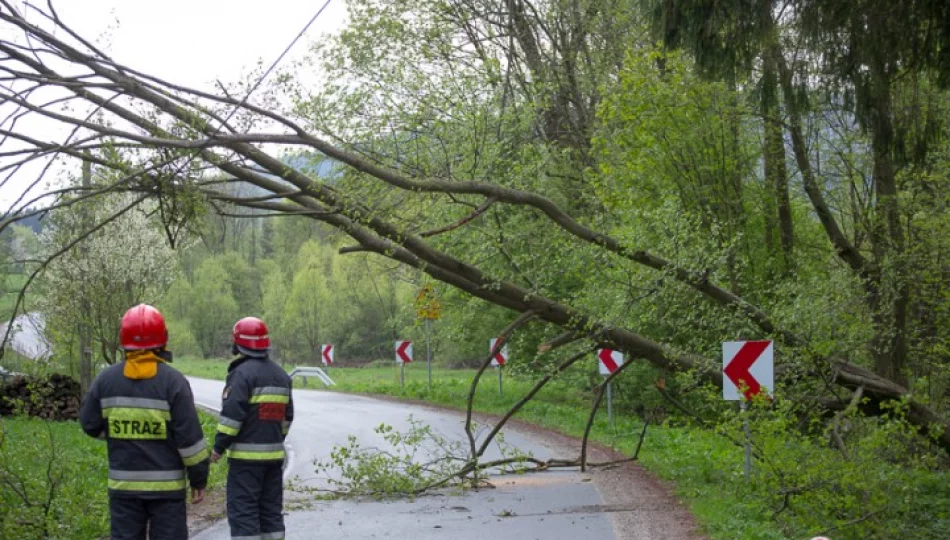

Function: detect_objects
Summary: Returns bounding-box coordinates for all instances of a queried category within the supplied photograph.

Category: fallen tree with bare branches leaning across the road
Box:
[0,1,950,459]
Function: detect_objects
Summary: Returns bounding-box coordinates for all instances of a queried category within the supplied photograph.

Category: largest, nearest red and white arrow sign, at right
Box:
[722,341,775,401]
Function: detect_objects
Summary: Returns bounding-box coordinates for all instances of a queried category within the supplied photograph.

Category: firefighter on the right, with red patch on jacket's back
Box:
[211,317,294,540]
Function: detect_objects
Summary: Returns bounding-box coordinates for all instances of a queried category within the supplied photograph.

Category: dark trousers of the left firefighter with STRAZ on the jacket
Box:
[109,497,188,540]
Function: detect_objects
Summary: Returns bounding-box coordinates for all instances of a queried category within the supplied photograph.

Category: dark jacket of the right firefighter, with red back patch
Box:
[214,356,294,463]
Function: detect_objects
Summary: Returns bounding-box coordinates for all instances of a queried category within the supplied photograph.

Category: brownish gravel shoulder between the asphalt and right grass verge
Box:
[340,394,706,540]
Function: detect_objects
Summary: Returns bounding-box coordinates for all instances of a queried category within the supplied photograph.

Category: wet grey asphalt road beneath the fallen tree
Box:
[189,378,616,540]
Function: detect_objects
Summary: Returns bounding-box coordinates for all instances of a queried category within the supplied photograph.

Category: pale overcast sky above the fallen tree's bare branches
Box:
[0,0,346,212]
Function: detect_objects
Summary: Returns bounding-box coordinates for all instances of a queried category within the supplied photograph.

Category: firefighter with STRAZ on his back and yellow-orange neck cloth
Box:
[80,304,208,540]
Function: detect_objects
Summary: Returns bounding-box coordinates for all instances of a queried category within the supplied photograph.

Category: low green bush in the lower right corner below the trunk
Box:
[722,396,950,540]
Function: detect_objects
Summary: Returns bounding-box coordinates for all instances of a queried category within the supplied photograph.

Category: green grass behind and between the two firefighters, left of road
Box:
[0,412,227,539]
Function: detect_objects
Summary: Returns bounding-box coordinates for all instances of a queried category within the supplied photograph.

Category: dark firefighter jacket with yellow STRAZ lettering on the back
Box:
[79,362,208,499]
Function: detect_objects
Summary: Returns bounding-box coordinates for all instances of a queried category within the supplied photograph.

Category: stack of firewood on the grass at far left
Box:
[0,374,82,420]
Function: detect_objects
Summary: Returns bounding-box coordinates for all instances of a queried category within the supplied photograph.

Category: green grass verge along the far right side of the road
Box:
[175,359,785,540]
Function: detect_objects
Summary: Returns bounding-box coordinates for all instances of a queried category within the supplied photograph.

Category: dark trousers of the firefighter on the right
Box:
[228,459,284,540]
